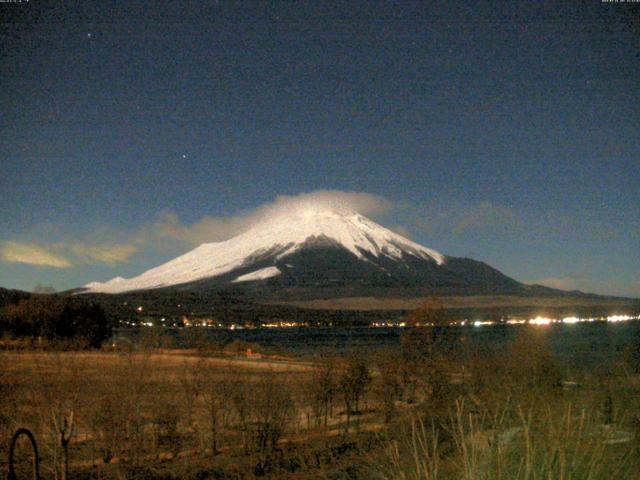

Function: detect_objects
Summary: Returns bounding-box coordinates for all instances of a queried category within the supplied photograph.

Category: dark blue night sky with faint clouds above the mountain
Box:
[0,0,640,296]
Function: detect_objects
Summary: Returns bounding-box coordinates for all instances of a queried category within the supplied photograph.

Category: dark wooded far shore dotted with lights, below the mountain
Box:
[0,288,640,327]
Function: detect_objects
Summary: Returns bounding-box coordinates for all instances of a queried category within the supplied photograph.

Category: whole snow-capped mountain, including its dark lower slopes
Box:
[79,204,530,297]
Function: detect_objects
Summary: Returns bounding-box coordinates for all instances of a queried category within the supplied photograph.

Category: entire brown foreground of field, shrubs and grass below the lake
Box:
[0,329,640,480]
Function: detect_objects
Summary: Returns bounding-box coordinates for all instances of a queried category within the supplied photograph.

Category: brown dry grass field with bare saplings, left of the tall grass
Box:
[0,350,380,478]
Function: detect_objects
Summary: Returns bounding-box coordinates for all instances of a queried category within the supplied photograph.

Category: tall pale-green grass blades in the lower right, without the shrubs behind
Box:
[371,403,638,480]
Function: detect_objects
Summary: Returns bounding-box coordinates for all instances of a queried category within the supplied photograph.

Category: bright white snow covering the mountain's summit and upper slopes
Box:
[84,205,445,293]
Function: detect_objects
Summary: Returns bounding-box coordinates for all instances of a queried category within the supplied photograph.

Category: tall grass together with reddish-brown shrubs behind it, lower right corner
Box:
[370,329,640,480]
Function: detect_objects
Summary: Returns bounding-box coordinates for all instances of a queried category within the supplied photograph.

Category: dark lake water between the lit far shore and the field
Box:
[117,321,640,363]
